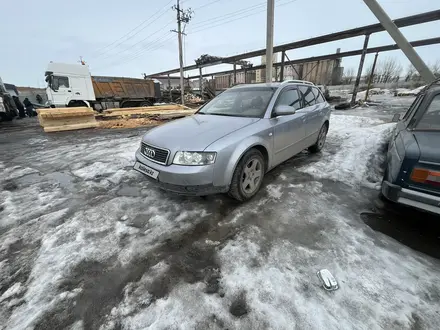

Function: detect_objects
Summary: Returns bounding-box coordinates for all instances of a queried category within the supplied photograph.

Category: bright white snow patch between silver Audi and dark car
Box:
[300,115,395,187]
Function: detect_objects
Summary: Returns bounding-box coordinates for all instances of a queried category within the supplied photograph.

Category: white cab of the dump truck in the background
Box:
[45,62,96,107]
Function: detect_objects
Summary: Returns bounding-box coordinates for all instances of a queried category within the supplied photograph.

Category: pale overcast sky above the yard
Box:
[0,0,440,87]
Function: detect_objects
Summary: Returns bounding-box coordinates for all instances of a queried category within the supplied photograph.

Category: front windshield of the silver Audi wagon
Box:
[198,87,275,118]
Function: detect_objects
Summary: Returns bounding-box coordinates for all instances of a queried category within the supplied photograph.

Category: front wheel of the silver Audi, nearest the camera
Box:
[229,149,265,202]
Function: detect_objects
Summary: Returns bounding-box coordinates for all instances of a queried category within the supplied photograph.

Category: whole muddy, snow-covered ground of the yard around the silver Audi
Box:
[0,98,440,329]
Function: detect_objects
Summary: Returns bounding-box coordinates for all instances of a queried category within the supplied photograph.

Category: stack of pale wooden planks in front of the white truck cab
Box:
[37,107,98,133]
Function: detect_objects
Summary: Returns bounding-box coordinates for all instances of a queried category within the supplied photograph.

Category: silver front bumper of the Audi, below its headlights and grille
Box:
[136,149,229,196]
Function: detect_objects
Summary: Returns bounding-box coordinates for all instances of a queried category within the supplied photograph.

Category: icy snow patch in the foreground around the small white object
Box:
[99,181,440,329]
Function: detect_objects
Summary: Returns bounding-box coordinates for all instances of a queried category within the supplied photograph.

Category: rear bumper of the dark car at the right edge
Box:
[382,181,440,215]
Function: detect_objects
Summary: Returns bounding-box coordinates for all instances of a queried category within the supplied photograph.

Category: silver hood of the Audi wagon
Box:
[142,114,260,151]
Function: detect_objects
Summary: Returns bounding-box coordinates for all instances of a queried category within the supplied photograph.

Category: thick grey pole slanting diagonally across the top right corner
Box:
[364,0,435,84]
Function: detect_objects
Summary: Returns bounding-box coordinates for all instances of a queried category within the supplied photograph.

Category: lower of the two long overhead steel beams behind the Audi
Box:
[184,37,440,79]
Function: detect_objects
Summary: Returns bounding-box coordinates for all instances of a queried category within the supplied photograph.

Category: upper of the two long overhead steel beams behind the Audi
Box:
[147,9,440,77]
